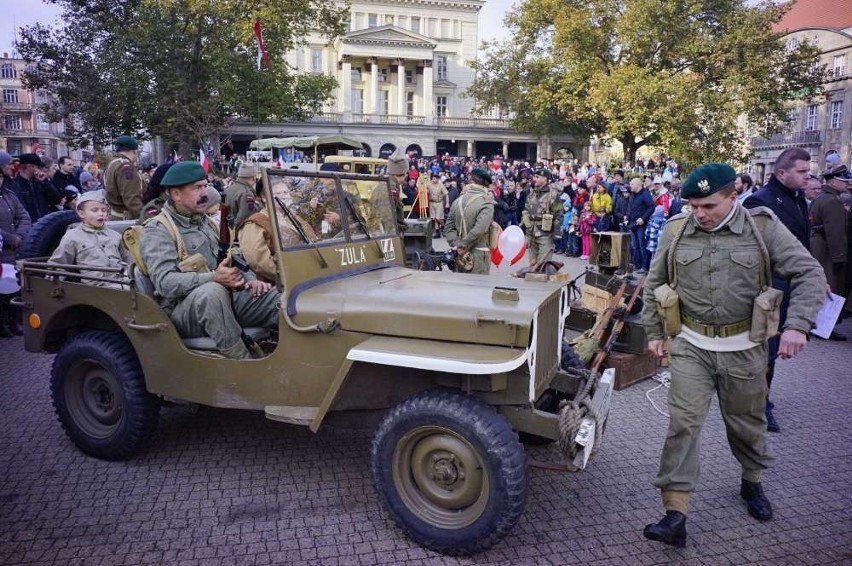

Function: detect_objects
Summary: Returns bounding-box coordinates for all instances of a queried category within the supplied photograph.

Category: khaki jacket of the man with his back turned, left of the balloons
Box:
[444,184,494,250]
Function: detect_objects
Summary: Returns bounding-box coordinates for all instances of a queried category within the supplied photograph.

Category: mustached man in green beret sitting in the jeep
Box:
[142,161,280,359]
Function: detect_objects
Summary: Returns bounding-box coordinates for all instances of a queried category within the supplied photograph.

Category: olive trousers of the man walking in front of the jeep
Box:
[654,336,773,492]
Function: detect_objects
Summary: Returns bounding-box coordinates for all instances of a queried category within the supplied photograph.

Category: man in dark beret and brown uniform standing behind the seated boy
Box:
[104,136,145,220]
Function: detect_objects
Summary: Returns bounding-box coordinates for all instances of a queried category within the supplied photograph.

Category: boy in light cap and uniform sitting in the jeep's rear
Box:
[48,191,131,288]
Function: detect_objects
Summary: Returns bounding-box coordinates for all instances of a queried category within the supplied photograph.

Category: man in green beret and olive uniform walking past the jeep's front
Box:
[642,163,825,547]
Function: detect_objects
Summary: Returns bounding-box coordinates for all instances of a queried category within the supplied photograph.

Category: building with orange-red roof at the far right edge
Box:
[747,0,852,182]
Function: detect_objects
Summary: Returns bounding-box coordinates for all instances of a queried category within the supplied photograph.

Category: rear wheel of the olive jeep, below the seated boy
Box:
[50,330,160,460]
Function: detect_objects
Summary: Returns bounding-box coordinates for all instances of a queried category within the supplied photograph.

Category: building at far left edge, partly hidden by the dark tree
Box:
[0,53,79,159]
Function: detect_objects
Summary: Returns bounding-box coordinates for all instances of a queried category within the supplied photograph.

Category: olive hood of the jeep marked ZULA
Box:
[287,267,563,348]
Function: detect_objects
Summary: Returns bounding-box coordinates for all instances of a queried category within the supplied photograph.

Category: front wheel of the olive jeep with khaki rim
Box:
[372,389,527,555]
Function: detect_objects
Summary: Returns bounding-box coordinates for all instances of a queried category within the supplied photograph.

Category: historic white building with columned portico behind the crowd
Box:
[224,0,587,160]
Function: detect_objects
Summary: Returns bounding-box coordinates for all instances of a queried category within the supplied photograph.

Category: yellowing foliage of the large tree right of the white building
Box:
[467,0,826,161]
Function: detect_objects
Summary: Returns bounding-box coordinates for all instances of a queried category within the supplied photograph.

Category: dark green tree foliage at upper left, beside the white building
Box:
[18,0,346,154]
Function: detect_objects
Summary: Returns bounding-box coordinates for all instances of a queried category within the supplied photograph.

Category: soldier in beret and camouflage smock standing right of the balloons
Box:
[521,168,564,267]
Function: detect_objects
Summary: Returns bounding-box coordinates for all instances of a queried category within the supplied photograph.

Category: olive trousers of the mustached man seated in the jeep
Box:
[169,281,281,351]
